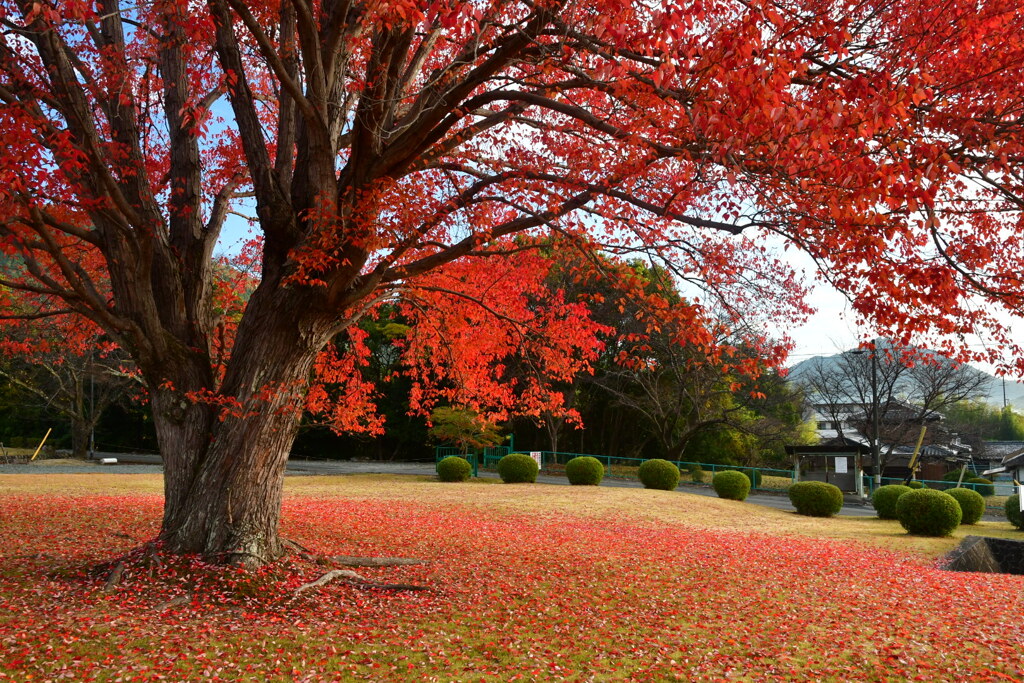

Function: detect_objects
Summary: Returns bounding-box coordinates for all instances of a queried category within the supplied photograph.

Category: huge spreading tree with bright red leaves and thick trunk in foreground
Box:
[0,0,1024,565]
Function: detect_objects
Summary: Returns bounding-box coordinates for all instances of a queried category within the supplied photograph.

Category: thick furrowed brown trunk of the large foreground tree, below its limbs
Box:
[154,290,328,567]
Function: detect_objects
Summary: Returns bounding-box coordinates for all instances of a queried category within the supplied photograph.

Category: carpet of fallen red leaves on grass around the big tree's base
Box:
[0,482,1024,681]
